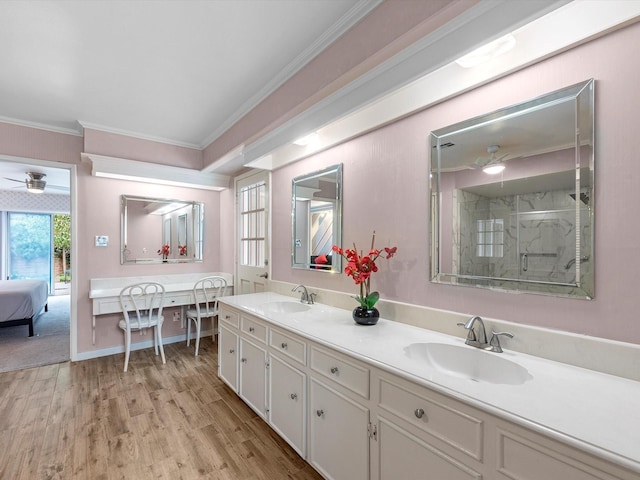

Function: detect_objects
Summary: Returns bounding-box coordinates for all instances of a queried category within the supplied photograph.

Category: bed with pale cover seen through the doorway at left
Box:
[0,280,49,337]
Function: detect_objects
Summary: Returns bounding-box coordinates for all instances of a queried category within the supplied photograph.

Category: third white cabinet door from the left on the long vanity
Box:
[269,355,307,457]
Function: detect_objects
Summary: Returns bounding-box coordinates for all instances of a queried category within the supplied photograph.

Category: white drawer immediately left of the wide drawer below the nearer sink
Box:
[311,347,369,399]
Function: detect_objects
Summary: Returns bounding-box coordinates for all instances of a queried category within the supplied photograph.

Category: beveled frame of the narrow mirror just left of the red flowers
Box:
[291,163,342,273]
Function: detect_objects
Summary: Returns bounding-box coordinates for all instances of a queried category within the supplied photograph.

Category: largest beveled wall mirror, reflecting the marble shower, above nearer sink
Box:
[430,80,594,299]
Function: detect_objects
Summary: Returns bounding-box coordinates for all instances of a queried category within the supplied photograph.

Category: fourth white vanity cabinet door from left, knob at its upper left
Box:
[309,378,369,480]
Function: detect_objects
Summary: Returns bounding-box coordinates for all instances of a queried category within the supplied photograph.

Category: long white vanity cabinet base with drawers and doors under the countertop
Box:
[218,305,640,480]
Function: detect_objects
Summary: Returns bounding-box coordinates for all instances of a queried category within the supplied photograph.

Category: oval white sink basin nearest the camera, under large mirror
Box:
[404,343,533,385]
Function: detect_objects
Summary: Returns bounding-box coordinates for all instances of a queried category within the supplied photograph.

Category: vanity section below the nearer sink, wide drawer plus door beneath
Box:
[371,372,487,480]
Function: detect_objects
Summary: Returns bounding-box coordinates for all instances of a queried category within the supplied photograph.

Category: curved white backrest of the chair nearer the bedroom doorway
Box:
[120,282,164,328]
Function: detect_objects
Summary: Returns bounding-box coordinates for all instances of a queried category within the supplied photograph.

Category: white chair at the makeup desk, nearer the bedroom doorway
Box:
[118,282,166,372]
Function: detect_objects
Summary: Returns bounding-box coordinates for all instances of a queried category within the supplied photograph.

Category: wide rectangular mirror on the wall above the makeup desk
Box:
[120,195,204,265]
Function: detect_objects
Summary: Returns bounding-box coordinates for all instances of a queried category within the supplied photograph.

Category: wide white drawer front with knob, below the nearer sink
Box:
[378,377,484,462]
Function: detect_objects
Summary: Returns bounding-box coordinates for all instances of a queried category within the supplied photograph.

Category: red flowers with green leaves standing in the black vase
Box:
[331,231,398,310]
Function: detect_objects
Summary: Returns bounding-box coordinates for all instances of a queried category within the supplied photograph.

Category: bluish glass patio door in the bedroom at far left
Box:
[7,212,53,294]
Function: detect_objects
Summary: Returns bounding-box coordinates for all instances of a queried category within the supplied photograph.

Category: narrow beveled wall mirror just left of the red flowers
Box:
[291,164,342,272]
